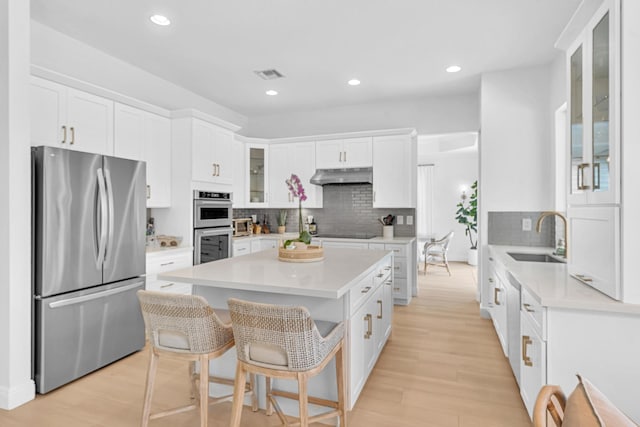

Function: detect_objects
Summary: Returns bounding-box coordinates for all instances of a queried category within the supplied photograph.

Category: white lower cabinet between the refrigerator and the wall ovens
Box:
[145,248,193,294]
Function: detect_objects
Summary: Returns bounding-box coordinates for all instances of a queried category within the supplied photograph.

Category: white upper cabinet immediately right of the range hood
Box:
[373,135,417,208]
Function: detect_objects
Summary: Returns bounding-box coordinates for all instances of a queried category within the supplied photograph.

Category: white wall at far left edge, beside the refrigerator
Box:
[0,0,35,409]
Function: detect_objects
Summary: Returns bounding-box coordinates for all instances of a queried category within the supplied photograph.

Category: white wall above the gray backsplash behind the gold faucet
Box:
[479,65,555,310]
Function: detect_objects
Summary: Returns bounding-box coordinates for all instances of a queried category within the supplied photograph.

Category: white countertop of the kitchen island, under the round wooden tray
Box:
[158,248,390,299]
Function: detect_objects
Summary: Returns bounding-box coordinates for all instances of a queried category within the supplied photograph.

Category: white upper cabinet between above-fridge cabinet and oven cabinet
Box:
[114,103,171,208]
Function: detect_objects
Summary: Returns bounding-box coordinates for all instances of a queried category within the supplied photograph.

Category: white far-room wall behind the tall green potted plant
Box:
[418,139,478,261]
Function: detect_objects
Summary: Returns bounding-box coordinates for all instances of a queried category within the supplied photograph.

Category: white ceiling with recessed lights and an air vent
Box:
[31,0,580,116]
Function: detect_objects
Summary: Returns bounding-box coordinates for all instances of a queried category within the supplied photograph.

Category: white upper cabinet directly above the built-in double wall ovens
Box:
[192,119,233,185]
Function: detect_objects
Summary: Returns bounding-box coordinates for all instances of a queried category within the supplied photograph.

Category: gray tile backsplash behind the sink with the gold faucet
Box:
[488,212,556,247]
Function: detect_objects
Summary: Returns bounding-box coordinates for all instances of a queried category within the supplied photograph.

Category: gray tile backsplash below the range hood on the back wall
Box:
[233,184,416,237]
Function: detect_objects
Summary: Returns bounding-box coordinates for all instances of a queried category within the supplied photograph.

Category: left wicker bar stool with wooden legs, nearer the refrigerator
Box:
[138,290,258,427]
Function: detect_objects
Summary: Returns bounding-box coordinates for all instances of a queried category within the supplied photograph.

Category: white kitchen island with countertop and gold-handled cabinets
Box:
[158,248,393,415]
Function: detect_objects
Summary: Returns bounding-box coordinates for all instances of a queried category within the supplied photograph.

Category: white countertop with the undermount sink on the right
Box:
[489,245,640,314]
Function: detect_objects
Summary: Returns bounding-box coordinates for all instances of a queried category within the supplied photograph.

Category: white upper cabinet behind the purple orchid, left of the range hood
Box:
[269,142,322,208]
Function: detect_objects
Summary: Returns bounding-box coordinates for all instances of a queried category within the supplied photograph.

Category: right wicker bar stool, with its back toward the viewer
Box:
[228,298,347,427]
